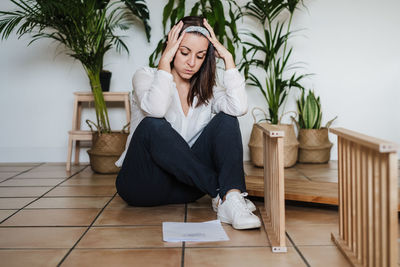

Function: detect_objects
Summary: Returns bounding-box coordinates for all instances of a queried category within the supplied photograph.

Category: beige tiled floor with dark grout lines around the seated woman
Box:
[0,163,388,267]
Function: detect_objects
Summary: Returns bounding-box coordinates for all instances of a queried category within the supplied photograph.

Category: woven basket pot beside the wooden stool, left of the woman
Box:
[88,132,128,174]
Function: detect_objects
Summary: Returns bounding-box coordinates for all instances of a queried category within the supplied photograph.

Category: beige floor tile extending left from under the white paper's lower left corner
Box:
[77,225,182,248]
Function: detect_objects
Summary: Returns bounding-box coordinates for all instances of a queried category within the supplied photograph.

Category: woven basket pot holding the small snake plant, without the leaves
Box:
[298,128,332,163]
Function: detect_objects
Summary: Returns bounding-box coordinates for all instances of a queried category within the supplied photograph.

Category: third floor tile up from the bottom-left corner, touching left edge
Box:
[1,209,100,226]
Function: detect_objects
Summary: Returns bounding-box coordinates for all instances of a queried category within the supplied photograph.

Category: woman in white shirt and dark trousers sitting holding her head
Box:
[116,16,261,229]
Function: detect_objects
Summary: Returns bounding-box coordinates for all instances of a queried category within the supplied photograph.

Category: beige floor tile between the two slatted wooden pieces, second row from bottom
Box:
[286,224,339,246]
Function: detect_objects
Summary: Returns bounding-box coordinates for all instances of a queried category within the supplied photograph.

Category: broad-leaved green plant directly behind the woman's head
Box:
[149,0,242,67]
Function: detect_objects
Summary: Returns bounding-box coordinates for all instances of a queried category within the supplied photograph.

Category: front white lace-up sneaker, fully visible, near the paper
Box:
[217,192,261,229]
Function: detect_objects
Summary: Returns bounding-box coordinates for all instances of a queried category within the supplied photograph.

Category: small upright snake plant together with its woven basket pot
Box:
[292,90,337,163]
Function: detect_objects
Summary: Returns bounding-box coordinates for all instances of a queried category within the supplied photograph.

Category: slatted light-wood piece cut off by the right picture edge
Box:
[330,128,398,266]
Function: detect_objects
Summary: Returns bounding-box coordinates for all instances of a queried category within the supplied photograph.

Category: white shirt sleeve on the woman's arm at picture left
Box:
[132,67,173,118]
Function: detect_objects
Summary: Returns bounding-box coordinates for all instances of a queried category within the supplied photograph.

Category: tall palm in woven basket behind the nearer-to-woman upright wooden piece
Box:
[240,0,307,167]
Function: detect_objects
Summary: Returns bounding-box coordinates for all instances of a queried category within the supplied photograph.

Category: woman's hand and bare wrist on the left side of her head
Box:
[158,21,185,72]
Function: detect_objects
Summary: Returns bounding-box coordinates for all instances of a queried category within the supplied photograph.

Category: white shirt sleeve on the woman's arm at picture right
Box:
[211,68,248,117]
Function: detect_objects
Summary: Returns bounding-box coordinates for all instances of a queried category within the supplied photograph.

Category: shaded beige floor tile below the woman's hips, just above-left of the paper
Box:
[94,205,185,225]
